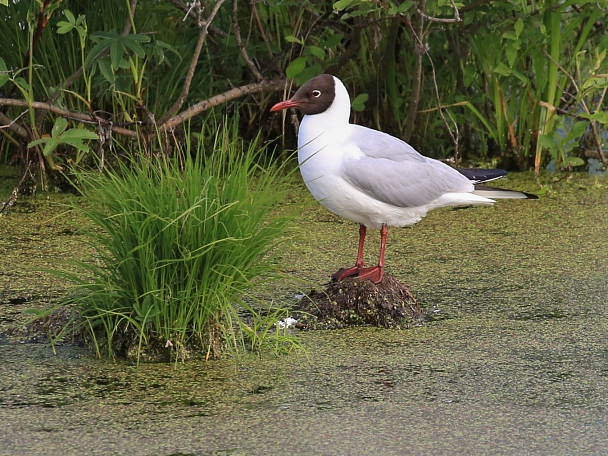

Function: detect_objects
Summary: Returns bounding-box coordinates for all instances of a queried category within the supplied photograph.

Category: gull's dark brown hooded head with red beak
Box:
[270,74,336,116]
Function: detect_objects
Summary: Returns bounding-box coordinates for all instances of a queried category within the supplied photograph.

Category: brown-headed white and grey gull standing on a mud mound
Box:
[270,74,537,284]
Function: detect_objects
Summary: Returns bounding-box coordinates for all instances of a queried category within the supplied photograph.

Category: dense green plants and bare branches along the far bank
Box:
[0,0,608,180]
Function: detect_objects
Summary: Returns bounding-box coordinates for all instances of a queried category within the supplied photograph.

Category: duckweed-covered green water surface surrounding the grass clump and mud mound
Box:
[0,170,608,455]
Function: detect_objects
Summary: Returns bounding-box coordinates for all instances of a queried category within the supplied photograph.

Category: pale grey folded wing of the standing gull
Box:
[342,127,474,207]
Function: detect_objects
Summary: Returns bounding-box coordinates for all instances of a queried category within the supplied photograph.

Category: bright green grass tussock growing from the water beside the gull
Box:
[64,132,297,360]
